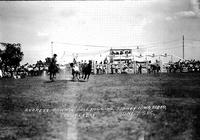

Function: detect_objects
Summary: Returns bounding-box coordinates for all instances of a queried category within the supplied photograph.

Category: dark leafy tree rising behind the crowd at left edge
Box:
[0,43,24,71]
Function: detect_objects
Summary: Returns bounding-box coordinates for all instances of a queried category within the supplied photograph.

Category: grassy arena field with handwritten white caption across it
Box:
[0,73,200,140]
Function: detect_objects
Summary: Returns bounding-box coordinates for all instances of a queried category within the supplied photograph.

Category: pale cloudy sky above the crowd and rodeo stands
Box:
[0,0,200,63]
